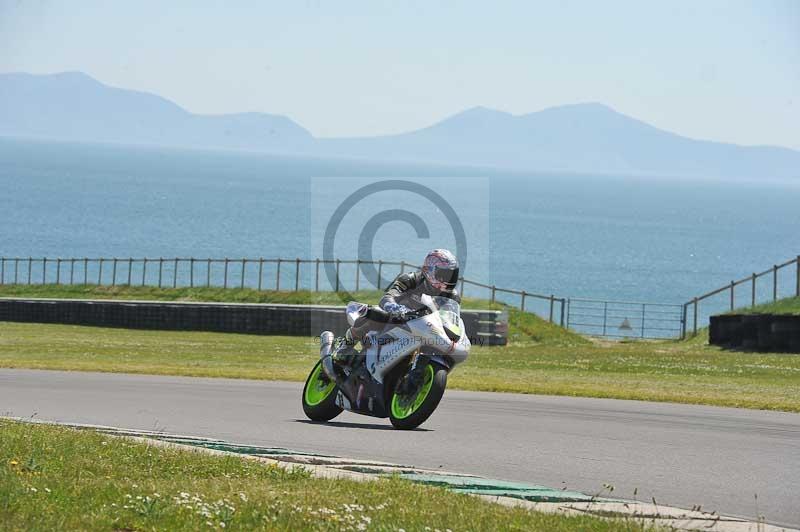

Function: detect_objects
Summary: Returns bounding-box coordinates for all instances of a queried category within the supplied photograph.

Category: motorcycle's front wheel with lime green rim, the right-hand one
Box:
[389,363,447,430]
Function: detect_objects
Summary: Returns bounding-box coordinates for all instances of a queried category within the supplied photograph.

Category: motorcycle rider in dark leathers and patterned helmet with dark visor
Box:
[332,249,461,366]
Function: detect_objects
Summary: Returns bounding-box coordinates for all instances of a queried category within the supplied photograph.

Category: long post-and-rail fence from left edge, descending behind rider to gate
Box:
[0,257,566,326]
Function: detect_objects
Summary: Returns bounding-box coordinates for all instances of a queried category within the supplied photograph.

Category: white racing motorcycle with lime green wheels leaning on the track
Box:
[303,294,470,429]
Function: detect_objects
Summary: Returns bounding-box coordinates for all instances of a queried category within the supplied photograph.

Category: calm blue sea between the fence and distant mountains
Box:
[0,139,800,320]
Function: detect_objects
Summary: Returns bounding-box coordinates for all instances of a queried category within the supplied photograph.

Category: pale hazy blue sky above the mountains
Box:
[0,0,800,149]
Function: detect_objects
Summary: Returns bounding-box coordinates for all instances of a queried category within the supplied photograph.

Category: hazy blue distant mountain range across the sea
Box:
[0,72,800,179]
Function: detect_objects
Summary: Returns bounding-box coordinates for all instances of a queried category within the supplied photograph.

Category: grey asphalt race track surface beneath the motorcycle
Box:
[0,369,800,528]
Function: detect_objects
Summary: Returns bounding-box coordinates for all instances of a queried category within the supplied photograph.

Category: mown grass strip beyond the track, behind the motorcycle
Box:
[0,286,800,412]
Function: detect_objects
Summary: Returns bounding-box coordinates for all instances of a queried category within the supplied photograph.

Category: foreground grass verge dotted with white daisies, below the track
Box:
[0,420,643,531]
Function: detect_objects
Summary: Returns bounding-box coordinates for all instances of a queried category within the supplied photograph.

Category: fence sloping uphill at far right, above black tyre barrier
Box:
[681,255,800,338]
